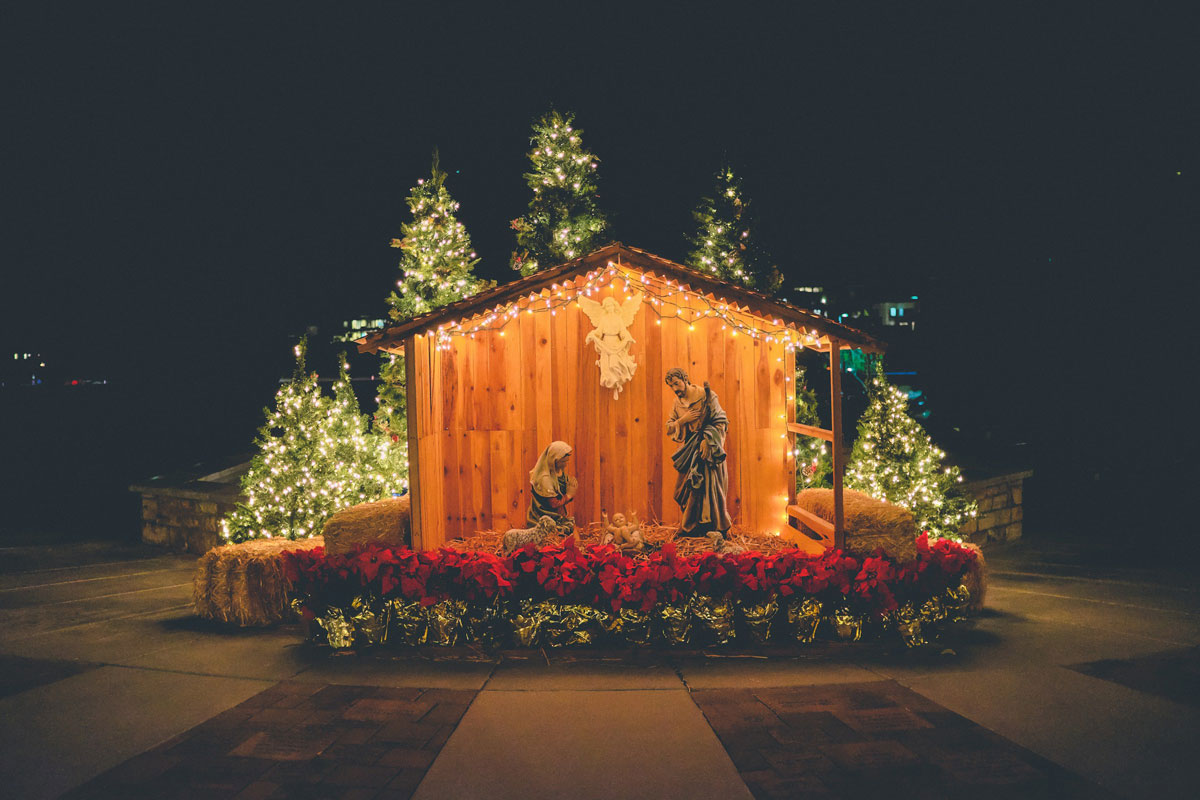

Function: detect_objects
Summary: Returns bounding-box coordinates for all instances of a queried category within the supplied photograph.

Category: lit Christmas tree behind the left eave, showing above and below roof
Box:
[376,151,493,448]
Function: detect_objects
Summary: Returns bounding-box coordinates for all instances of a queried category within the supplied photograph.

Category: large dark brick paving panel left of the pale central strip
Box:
[66,681,476,800]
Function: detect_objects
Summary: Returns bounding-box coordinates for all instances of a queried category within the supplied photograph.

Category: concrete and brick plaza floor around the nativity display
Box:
[0,532,1200,799]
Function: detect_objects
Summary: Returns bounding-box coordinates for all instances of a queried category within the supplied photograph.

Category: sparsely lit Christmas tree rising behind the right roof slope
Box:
[688,167,782,294]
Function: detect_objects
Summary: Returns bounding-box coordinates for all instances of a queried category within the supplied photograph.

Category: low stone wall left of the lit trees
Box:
[130,464,247,554]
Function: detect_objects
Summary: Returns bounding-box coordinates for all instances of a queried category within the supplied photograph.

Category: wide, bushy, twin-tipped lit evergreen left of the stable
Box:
[221,342,404,542]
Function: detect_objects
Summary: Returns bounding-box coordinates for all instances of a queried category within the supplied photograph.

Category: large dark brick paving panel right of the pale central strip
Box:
[692,680,1109,800]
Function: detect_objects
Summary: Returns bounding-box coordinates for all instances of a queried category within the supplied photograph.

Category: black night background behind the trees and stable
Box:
[0,2,1200,541]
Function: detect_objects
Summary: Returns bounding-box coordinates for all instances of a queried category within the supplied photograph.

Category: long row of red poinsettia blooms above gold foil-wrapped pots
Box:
[283,536,976,614]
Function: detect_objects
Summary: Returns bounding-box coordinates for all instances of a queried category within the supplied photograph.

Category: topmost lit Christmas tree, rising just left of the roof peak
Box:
[510,112,608,275]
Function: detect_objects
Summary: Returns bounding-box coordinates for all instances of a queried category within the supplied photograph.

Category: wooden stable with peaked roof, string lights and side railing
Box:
[358,243,881,549]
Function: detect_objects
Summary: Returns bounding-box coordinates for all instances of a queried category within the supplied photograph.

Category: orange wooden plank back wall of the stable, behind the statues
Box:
[414,272,793,547]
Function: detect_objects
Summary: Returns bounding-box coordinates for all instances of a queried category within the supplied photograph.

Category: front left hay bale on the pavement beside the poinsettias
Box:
[192,536,324,627]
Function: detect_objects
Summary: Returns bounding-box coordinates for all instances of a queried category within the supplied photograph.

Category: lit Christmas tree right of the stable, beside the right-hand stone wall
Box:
[846,366,976,539]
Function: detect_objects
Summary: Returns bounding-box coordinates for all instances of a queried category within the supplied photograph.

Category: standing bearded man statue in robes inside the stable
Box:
[666,367,733,536]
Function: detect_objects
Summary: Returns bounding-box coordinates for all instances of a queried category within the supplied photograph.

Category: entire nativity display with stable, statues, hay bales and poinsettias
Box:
[196,243,983,649]
